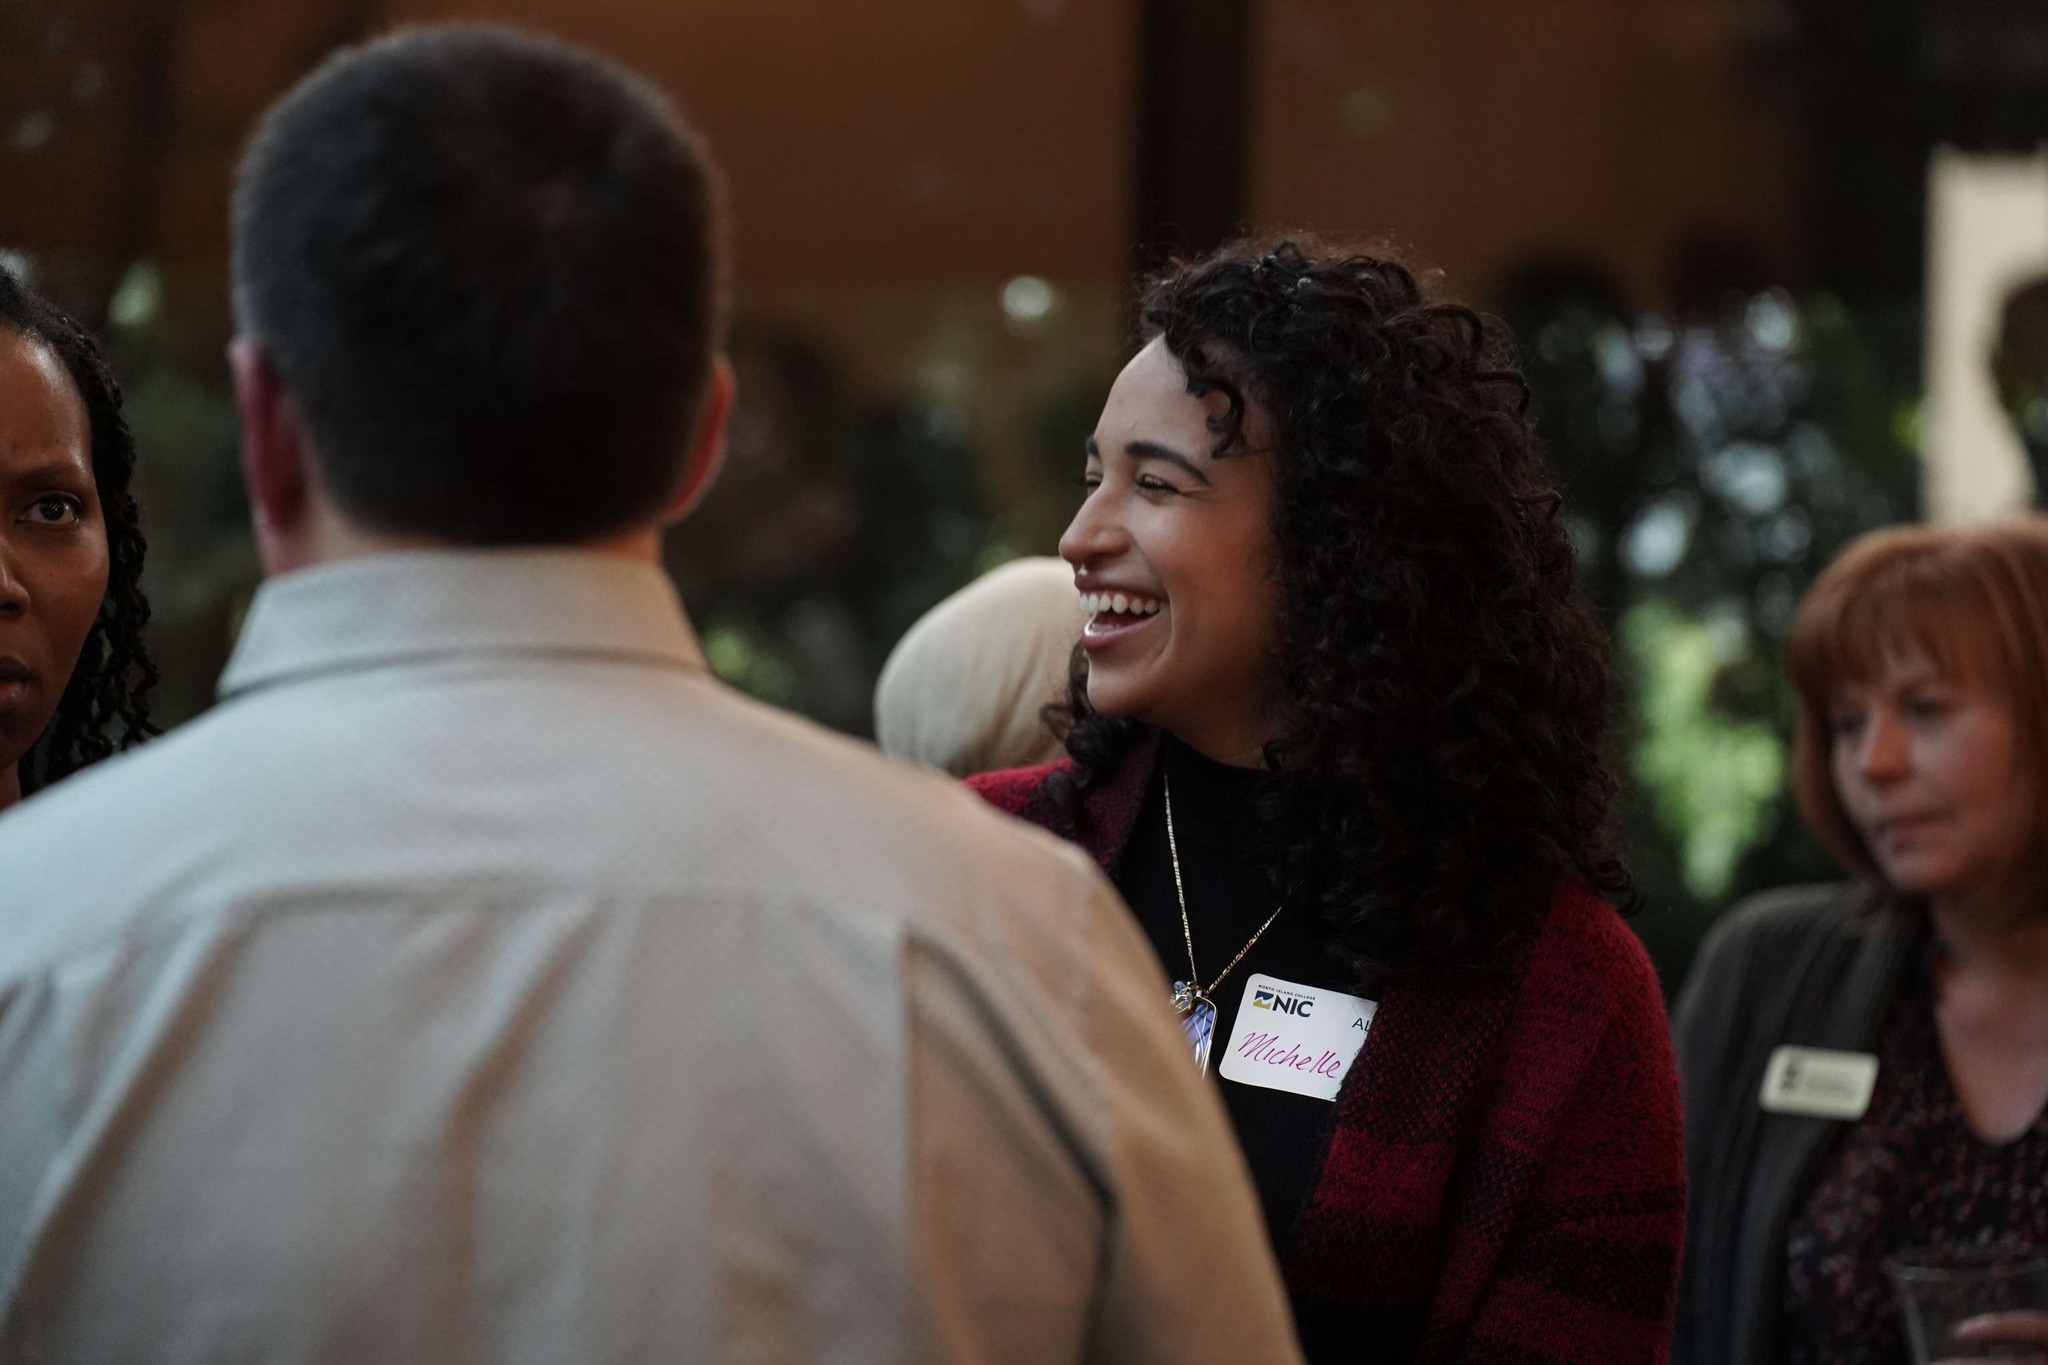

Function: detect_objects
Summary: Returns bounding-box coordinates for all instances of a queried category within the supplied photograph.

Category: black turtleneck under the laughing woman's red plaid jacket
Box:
[1114,735,1358,1250]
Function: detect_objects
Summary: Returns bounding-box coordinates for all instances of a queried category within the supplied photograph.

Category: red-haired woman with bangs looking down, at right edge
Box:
[1675,520,2048,1365]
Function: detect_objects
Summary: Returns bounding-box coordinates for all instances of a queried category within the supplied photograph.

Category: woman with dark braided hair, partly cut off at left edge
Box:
[0,270,156,810]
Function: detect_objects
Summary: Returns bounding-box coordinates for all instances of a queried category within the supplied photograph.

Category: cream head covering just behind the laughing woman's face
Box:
[874,557,1081,778]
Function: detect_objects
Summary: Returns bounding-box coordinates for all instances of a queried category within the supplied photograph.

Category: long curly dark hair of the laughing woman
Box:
[1053,237,1632,972]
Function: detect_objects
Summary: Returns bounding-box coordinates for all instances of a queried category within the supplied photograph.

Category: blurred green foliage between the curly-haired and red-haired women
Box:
[1499,266,1921,990]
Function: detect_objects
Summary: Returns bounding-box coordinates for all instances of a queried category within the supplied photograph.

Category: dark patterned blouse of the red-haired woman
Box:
[1784,954,2048,1365]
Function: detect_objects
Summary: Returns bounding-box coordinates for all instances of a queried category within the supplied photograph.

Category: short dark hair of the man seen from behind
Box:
[233,25,723,544]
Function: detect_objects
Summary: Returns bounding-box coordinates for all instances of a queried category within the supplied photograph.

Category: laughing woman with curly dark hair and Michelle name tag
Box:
[975,239,1683,1361]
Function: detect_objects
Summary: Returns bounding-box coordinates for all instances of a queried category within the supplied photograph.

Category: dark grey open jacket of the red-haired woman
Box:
[1671,886,1925,1365]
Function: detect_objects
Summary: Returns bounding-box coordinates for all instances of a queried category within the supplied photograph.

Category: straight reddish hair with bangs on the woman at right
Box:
[1786,518,2048,876]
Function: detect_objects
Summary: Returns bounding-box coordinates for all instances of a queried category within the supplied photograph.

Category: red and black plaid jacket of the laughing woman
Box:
[971,745,1686,1365]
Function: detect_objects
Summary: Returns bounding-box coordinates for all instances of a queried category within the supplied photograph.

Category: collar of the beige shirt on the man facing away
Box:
[219,548,705,700]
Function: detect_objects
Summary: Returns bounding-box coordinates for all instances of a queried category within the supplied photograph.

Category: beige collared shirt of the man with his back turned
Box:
[0,551,1294,1365]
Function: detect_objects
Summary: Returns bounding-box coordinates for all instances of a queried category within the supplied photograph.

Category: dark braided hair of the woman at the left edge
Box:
[0,268,156,796]
